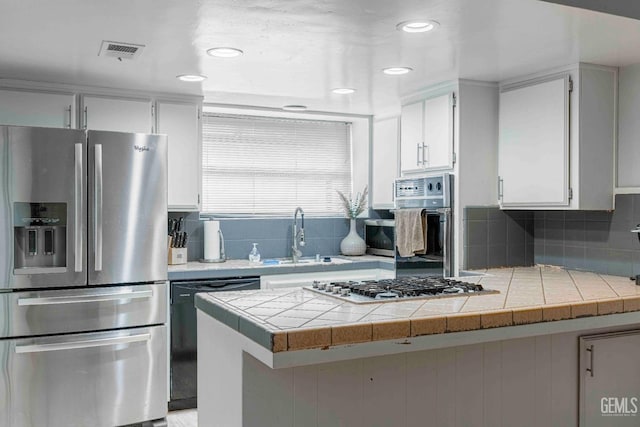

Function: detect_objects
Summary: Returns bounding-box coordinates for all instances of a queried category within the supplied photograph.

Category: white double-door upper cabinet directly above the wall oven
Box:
[400,92,455,174]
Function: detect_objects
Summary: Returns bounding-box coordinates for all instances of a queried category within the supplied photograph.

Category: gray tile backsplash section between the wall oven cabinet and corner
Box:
[463,206,534,269]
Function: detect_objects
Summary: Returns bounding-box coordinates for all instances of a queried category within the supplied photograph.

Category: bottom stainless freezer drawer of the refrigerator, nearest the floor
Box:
[0,326,167,427]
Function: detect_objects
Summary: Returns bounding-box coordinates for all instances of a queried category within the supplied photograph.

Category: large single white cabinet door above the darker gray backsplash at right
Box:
[498,75,570,207]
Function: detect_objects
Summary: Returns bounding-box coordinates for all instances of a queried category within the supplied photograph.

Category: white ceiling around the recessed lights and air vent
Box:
[0,0,640,114]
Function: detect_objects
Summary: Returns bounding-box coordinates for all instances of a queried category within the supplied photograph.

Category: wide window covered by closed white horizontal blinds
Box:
[202,113,352,215]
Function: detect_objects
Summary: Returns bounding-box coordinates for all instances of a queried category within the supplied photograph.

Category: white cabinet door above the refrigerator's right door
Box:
[80,95,155,133]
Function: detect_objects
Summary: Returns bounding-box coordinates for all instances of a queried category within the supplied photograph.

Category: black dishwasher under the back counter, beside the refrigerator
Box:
[169,277,260,410]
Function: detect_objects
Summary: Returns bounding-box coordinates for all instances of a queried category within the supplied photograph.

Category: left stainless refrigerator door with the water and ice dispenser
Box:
[0,126,87,290]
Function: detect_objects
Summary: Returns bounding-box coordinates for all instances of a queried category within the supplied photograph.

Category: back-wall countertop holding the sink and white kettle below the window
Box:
[168,255,395,280]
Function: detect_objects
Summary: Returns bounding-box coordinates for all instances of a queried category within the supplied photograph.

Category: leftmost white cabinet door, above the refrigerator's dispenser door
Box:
[0,89,76,128]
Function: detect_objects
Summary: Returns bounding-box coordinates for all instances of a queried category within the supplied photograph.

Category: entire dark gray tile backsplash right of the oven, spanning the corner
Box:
[463,194,640,276]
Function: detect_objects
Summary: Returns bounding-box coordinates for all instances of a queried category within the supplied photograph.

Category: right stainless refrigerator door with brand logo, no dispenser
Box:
[88,131,167,285]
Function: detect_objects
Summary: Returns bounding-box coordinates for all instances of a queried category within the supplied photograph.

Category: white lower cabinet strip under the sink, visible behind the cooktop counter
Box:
[260,268,396,289]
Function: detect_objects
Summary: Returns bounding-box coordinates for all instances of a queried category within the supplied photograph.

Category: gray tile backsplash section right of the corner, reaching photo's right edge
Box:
[534,194,640,276]
